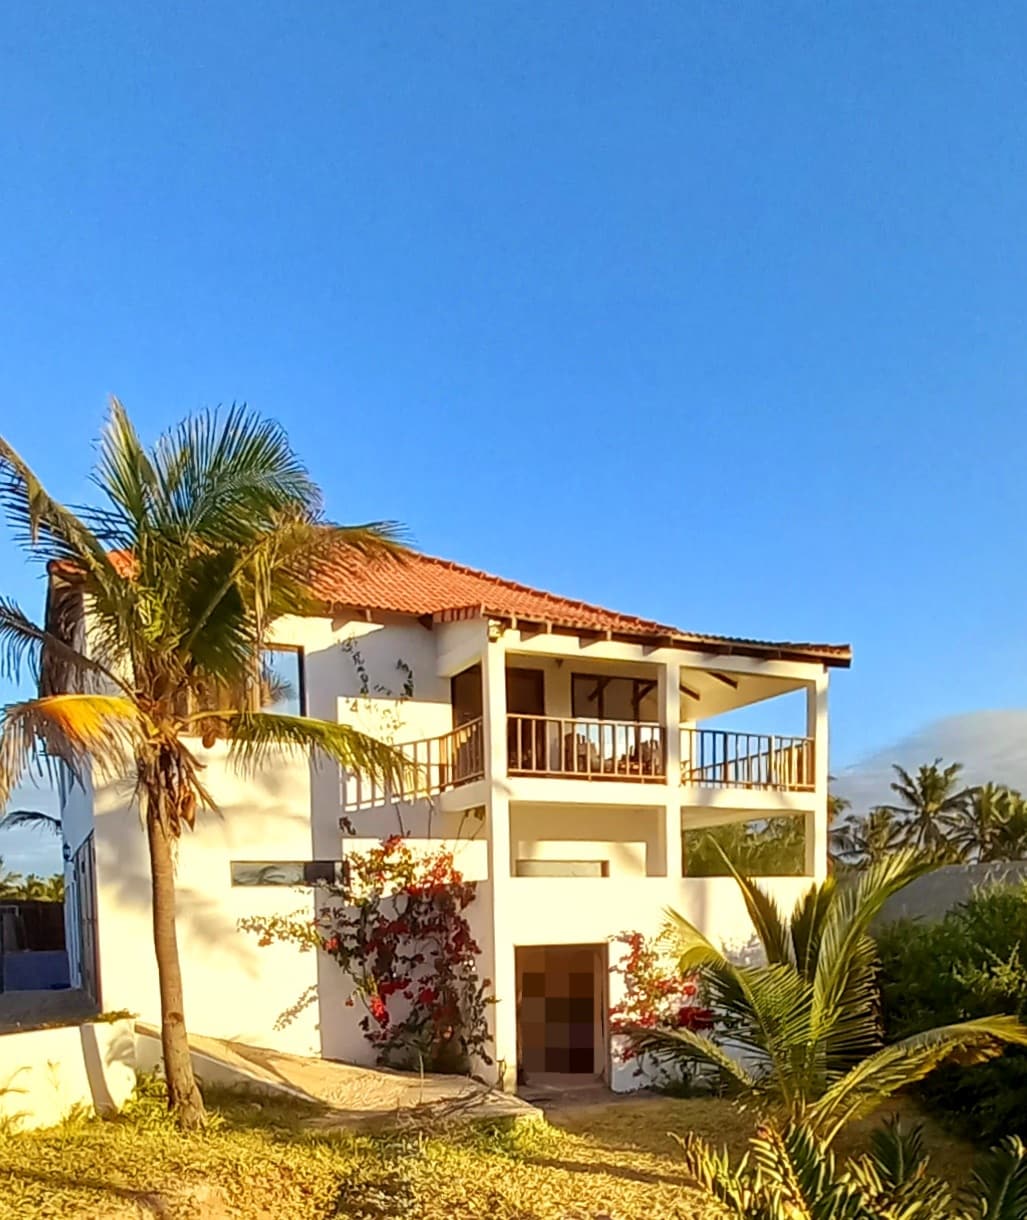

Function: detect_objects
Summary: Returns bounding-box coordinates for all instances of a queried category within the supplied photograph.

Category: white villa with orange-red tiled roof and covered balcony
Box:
[51,556,850,1088]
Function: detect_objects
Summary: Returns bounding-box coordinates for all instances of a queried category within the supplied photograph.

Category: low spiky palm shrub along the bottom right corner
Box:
[679,1122,1027,1220]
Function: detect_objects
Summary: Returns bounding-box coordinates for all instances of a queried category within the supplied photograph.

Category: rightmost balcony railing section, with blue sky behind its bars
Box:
[681,728,816,792]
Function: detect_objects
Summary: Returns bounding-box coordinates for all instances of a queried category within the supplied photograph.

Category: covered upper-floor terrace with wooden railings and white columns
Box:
[350,633,827,805]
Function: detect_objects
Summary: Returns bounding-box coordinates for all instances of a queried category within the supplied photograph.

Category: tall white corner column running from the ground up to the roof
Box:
[482,639,517,1092]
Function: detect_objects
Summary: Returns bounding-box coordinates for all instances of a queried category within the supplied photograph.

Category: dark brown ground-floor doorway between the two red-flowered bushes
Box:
[516,944,609,1091]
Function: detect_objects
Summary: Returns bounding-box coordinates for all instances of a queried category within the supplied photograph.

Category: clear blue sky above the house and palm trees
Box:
[0,0,1027,873]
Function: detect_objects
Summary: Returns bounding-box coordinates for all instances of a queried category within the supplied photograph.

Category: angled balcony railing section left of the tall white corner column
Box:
[343,717,485,809]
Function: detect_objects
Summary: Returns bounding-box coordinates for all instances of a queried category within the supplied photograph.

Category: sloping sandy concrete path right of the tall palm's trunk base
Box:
[143,1025,542,1129]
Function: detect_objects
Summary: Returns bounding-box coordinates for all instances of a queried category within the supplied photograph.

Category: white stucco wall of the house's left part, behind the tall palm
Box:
[87,619,487,1061]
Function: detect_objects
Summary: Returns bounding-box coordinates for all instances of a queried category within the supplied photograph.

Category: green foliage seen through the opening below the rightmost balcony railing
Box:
[682,817,806,877]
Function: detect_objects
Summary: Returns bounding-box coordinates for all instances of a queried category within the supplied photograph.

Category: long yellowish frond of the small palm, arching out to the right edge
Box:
[807,1016,1027,1139]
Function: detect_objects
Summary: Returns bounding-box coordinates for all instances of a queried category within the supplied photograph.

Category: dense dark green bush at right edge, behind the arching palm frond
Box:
[877,883,1027,1142]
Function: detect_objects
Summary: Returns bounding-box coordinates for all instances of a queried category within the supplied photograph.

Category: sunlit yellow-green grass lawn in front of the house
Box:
[0,1091,972,1220]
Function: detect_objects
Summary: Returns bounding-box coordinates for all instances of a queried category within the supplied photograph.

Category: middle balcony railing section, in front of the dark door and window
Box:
[506,716,666,782]
